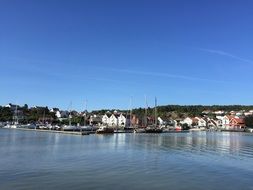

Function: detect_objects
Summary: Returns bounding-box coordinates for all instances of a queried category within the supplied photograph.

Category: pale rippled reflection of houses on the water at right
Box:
[113,132,253,162]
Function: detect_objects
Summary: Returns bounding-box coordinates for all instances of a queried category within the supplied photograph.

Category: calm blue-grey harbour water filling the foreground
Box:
[0,129,253,190]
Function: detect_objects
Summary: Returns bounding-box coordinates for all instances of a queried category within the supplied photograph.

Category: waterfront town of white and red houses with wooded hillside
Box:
[0,103,253,132]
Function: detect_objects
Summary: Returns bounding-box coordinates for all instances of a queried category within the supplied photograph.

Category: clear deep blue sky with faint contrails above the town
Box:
[0,0,253,110]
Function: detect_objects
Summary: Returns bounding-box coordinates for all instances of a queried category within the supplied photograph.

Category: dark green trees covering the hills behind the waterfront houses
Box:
[0,104,253,123]
